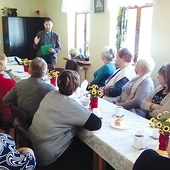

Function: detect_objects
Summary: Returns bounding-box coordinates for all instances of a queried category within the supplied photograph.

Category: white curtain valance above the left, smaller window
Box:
[61,0,90,13]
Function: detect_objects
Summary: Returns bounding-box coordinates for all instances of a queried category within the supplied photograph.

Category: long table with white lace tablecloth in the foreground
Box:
[78,99,161,170]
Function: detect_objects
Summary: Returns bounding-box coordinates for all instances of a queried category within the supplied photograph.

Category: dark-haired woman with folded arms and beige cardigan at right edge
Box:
[141,64,170,119]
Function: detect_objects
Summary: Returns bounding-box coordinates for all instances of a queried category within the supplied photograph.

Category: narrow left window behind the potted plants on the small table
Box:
[75,12,90,56]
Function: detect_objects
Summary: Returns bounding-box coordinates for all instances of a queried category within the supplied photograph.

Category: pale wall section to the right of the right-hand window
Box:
[151,0,170,86]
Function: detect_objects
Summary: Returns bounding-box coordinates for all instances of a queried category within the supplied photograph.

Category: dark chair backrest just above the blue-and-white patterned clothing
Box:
[14,123,33,149]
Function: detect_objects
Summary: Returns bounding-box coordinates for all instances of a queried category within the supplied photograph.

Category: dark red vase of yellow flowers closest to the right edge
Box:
[159,133,169,151]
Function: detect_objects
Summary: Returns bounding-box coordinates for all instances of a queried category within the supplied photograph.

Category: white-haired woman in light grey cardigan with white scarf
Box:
[116,58,155,117]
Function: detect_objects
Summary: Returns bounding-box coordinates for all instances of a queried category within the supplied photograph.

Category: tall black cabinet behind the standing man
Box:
[2,16,45,59]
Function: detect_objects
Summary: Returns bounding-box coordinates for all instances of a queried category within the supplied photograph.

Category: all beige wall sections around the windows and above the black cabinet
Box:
[0,0,170,86]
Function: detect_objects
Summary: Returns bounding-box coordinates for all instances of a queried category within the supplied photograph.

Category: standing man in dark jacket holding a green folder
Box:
[33,18,61,68]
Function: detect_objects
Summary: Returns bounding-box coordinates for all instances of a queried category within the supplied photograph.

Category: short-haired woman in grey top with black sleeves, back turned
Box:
[29,70,101,170]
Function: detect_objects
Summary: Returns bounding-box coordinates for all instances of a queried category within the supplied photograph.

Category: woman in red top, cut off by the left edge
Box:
[0,53,15,122]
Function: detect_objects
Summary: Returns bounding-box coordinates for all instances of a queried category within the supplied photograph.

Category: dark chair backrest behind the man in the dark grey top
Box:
[10,105,33,131]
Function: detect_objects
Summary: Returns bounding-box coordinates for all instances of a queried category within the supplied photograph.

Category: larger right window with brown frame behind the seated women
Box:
[123,4,153,61]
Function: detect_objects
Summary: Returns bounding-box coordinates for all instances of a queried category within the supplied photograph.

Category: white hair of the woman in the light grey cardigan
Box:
[137,57,155,73]
